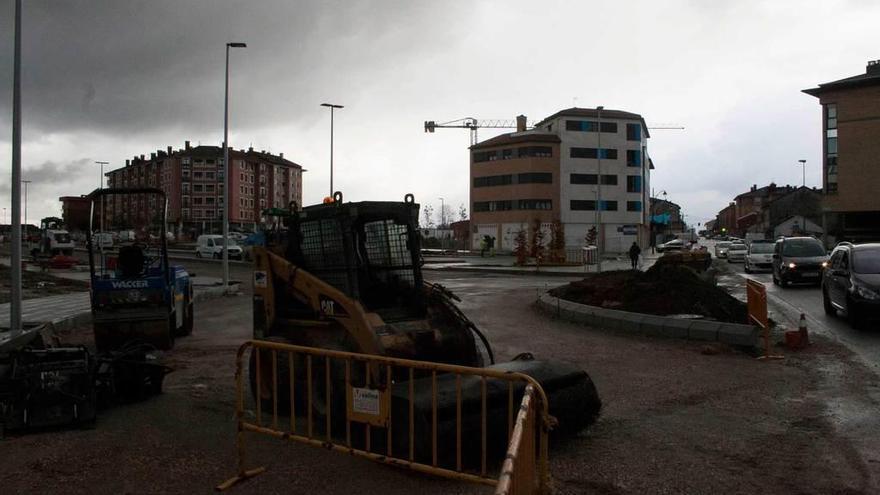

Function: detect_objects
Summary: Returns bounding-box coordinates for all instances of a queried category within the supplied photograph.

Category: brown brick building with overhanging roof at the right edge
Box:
[803,60,880,247]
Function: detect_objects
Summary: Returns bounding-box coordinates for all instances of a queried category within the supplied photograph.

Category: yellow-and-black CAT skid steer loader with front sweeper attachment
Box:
[250,192,601,462]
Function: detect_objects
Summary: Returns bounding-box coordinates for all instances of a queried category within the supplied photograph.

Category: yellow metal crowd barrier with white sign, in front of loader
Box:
[216,340,553,494]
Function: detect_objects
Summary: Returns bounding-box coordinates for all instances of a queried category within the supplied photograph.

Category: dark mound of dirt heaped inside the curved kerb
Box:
[550,265,748,323]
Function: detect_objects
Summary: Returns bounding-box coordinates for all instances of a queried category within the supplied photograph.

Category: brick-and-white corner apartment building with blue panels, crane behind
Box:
[470,108,653,253]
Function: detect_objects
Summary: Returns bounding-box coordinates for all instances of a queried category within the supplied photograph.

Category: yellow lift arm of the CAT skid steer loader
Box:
[253,246,384,356]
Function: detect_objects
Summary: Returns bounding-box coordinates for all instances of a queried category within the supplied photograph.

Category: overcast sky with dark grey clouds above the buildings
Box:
[0,0,880,227]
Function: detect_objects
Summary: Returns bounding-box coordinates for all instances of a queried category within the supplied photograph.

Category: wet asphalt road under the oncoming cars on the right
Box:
[704,241,880,373]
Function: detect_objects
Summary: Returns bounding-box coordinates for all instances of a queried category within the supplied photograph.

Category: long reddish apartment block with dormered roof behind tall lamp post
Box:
[106,141,303,234]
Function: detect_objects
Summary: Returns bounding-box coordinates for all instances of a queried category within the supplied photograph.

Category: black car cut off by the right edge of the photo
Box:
[822,243,880,328]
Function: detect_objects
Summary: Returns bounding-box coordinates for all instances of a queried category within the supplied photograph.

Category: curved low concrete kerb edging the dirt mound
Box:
[536,294,759,347]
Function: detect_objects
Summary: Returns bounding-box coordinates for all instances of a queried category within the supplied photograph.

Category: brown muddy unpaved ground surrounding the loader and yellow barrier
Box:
[0,273,880,495]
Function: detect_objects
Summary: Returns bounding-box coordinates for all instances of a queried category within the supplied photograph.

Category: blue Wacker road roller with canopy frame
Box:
[87,188,193,351]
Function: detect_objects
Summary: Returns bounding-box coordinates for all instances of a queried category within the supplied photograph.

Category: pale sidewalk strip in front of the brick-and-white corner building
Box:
[422,252,661,277]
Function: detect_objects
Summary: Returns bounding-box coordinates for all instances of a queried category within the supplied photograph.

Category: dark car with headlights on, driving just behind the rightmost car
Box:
[773,237,828,287]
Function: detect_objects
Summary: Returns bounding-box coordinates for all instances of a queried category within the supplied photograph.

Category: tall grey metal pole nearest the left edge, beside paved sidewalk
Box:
[9,0,22,338]
